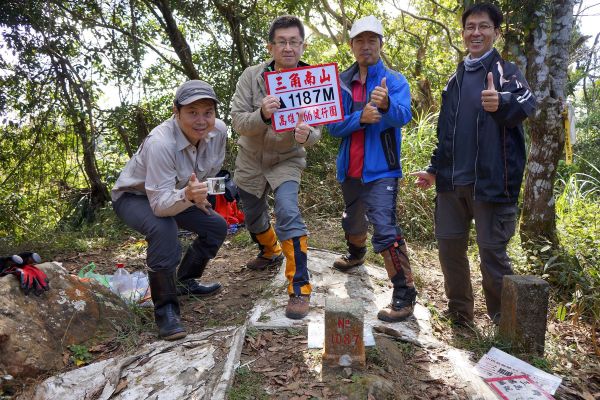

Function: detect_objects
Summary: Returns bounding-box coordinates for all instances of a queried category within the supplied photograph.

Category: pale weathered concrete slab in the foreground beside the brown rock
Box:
[34,326,246,400]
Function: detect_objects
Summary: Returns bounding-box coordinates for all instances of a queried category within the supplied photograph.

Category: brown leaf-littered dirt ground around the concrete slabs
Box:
[0,220,600,400]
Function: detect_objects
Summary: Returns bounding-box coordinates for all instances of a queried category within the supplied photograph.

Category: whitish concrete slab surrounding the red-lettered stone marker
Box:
[250,248,439,348]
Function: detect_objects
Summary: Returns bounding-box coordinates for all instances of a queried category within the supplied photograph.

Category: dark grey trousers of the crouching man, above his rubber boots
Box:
[113,193,227,272]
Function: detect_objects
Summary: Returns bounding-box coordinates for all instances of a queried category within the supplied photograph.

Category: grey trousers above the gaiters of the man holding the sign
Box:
[238,181,308,241]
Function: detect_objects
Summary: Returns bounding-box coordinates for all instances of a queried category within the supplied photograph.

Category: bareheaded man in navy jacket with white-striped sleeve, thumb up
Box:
[415,3,536,324]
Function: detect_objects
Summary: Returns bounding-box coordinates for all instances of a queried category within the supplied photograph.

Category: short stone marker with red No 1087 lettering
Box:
[323,296,366,368]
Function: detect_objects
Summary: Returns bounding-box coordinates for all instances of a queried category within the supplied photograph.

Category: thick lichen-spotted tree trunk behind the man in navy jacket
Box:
[520,0,574,245]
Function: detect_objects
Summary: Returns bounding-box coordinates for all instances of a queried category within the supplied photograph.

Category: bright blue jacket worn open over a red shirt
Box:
[328,59,412,183]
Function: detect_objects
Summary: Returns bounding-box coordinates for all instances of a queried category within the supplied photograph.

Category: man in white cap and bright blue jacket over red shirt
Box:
[329,16,417,322]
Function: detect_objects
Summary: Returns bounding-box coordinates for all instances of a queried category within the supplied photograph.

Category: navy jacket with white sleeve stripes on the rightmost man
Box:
[427,49,536,203]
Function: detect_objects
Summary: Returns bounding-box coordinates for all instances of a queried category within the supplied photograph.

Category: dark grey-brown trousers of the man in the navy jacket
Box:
[435,185,517,322]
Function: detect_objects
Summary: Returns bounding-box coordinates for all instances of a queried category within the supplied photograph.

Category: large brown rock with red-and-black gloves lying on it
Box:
[0,262,132,378]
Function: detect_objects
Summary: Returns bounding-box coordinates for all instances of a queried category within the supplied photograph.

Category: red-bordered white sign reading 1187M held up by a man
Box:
[265,63,344,132]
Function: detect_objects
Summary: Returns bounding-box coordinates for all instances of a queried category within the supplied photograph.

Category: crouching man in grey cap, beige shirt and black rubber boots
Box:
[112,80,227,340]
